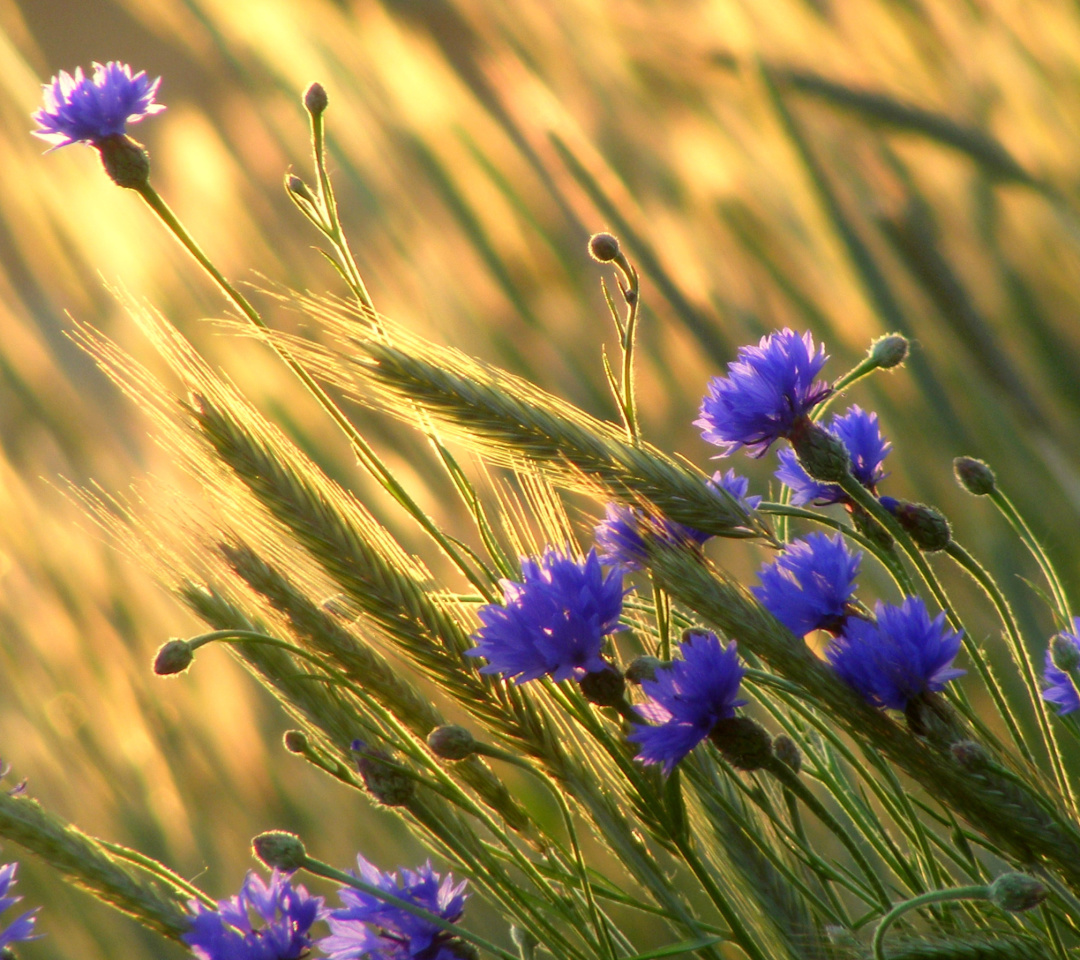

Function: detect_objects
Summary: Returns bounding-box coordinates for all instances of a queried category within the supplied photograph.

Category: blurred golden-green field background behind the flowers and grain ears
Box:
[6,0,1080,960]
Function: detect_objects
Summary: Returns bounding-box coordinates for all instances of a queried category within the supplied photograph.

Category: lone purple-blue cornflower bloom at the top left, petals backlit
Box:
[32,60,165,149]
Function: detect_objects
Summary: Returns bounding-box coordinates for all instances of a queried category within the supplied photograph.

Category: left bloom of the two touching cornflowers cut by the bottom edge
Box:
[180,869,327,960]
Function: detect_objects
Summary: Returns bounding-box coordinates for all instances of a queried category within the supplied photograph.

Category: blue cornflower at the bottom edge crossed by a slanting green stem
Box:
[318,856,468,960]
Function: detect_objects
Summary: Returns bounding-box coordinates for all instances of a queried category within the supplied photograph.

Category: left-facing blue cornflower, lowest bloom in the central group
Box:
[626,631,746,774]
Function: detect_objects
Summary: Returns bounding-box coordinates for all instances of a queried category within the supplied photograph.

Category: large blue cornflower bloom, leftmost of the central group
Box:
[465,546,626,684]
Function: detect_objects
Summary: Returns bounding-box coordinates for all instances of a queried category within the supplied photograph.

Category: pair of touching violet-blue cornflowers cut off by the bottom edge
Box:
[183,856,471,960]
